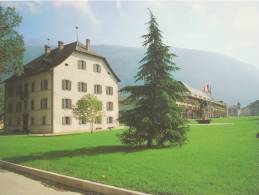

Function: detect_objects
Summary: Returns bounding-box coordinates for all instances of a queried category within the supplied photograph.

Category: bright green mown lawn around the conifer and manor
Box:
[0,117,259,195]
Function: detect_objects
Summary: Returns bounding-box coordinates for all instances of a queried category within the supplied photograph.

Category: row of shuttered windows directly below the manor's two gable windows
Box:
[7,79,113,97]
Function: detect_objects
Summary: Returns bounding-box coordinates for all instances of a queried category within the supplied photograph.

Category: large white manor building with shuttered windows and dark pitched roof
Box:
[5,39,120,133]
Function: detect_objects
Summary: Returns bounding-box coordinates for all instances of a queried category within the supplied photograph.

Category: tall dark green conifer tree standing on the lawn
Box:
[121,10,187,147]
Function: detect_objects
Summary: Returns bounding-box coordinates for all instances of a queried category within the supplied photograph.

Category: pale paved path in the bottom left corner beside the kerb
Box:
[0,168,86,195]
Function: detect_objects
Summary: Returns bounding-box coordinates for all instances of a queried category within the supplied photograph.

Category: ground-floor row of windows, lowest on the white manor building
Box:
[8,116,113,126]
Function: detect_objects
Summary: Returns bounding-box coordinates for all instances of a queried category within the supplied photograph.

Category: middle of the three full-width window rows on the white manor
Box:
[7,98,113,113]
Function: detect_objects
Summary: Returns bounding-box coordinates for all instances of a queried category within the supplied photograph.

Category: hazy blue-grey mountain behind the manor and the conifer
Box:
[24,45,259,107]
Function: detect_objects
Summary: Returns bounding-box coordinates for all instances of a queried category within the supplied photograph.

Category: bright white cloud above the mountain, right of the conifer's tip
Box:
[139,1,259,67]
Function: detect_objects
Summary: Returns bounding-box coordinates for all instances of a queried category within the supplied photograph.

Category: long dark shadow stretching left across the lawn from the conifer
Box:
[3,145,172,163]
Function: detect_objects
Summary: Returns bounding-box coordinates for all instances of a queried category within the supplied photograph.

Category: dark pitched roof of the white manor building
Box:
[6,41,120,82]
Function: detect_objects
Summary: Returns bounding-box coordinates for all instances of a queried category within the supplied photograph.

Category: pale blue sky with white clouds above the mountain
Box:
[2,0,259,68]
